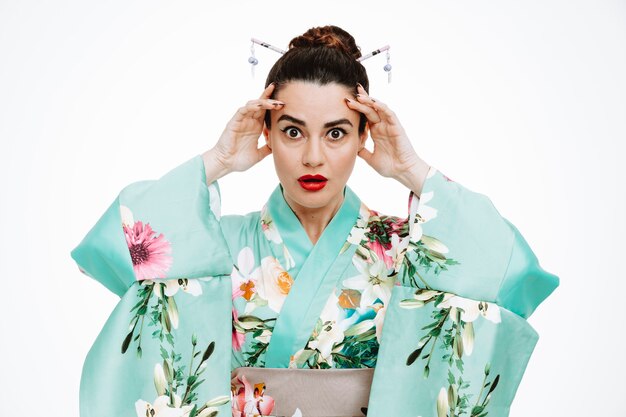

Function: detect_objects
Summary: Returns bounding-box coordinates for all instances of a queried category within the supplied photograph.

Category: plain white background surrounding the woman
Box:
[0,0,626,417]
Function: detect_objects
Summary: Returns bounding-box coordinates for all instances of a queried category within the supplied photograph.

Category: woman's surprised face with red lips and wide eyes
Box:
[263,81,367,213]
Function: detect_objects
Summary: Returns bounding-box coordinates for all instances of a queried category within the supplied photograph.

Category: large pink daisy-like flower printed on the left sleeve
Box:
[122,221,172,281]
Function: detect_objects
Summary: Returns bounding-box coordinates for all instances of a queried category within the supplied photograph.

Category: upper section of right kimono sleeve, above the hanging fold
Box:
[402,167,559,312]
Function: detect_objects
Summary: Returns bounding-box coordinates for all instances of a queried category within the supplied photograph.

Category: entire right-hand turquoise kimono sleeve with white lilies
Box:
[368,168,559,417]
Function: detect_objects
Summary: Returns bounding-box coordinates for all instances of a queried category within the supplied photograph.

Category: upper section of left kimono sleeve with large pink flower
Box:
[71,155,232,297]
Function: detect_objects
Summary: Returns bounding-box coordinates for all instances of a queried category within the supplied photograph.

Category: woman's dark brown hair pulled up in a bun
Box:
[265,26,369,133]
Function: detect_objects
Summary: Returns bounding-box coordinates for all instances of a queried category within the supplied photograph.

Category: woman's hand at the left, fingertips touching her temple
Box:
[202,83,284,184]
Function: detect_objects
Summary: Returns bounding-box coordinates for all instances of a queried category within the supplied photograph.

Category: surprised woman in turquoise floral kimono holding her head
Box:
[72,26,558,417]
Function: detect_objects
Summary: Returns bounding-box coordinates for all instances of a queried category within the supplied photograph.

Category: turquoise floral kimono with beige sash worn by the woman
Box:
[71,156,559,417]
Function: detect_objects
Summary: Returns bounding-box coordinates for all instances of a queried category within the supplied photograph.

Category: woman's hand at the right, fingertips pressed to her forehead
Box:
[346,85,430,196]
